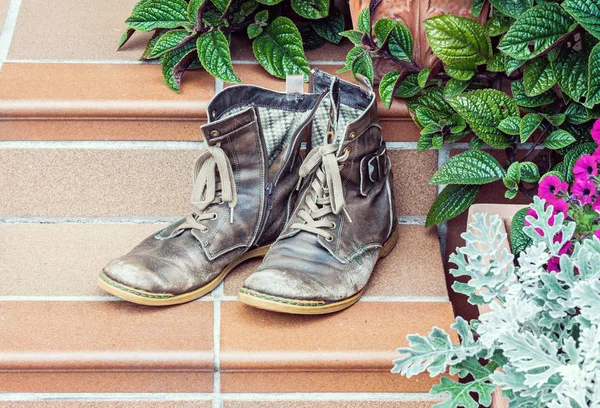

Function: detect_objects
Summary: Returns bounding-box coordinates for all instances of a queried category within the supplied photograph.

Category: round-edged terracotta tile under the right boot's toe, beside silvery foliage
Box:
[221,301,453,392]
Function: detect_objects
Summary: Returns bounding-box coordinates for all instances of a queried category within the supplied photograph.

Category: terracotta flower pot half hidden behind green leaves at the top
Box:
[349,0,488,78]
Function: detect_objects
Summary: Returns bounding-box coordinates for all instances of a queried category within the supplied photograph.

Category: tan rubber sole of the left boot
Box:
[98,245,271,306]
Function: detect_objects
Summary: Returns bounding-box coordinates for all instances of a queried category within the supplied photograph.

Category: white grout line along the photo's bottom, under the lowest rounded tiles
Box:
[0,392,442,402]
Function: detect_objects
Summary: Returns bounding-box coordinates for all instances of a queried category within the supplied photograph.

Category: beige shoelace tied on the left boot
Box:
[177,145,237,233]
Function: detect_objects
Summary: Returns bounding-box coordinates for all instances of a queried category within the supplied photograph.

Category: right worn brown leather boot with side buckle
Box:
[239,72,398,314]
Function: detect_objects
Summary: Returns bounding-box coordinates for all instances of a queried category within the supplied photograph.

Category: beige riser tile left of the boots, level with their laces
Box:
[0,149,200,217]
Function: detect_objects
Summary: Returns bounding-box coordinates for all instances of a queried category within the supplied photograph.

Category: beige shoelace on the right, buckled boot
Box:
[291,144,352,242]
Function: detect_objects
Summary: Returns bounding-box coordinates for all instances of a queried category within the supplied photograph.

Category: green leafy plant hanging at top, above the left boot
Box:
[119,0,344,92]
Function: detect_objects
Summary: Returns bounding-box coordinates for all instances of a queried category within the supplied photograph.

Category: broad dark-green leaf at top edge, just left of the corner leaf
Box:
[498,3,574,59]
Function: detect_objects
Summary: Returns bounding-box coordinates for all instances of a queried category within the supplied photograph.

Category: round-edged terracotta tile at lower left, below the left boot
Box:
[0,301,213,392]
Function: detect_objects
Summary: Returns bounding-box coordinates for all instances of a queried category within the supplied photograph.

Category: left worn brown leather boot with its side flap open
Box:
[98,85,325,306]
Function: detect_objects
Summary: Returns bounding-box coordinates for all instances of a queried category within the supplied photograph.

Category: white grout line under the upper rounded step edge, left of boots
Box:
[0,140,204,150]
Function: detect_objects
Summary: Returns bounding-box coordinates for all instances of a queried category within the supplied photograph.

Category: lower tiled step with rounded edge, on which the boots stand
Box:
[0,223,453,394]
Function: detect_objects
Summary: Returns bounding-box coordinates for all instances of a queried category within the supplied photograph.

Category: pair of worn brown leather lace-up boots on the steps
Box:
[98,70,398,314]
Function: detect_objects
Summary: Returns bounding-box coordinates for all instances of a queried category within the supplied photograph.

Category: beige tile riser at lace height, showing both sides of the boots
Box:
[0,147,437,218]
